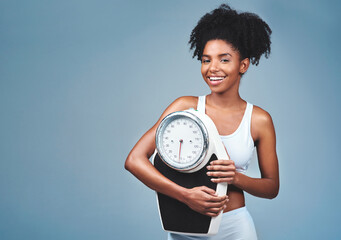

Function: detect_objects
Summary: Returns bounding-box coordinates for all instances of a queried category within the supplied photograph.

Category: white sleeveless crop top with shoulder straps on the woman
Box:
[197,96,255,173]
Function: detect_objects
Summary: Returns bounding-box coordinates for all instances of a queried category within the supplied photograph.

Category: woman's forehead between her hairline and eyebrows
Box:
[203,39,239,56]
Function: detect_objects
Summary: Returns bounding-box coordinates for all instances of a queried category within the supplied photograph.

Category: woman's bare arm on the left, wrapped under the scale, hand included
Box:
[125,97,227,217]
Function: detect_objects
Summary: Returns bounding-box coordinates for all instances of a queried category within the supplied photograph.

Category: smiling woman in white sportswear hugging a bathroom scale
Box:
[125,4,279,240]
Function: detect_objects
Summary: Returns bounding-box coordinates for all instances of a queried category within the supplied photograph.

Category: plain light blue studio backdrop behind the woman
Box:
[0,0,341,240]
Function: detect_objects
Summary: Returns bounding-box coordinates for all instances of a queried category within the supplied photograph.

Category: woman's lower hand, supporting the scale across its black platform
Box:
[185,186,228,217]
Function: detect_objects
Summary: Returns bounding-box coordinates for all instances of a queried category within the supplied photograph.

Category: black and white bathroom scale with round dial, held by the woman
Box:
[152,109,229,236]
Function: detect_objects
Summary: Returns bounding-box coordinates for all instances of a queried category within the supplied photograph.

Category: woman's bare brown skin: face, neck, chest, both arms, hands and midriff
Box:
[125,40,279,217]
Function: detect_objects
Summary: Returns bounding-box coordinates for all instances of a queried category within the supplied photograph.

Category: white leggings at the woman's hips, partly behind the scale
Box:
[168,207,257,240]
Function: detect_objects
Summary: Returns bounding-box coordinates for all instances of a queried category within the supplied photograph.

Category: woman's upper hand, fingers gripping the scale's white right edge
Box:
[207,160,236,184]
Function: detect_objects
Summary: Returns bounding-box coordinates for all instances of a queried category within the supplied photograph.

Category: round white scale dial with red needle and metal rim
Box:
[156,111,208,171]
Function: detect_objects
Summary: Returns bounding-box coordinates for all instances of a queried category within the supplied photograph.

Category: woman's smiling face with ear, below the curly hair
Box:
[201,39,250,93]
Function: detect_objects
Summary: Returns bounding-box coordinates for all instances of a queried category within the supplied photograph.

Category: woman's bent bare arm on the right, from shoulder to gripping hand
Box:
[208,108,279,199]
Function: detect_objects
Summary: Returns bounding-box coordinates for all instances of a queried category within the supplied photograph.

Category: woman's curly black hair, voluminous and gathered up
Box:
[188,4,272,65]
